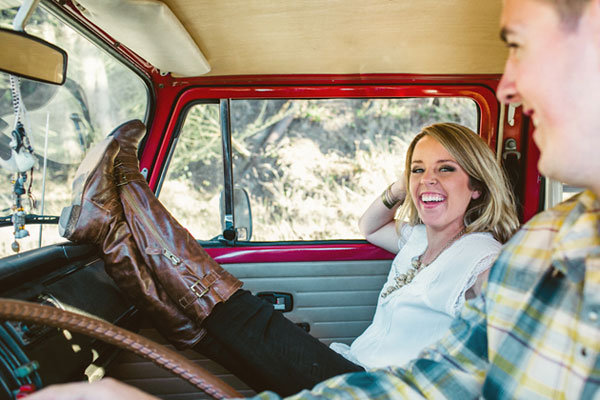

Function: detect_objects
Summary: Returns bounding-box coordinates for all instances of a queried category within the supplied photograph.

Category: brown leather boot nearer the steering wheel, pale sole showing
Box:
[59,122,204,348]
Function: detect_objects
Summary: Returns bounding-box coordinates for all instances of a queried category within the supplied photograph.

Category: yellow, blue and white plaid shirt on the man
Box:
[254,191,600,399]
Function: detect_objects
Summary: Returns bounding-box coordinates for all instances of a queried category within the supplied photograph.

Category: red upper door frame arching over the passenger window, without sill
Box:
[140,75,499,189]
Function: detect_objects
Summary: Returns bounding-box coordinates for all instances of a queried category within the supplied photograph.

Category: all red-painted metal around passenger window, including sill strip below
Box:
[140,74,538,263]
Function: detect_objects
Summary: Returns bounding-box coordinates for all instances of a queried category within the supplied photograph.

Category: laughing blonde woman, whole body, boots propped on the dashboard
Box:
[60,121,518,395]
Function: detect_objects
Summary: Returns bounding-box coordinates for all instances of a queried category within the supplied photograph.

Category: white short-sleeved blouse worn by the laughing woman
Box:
[330,224,501,368]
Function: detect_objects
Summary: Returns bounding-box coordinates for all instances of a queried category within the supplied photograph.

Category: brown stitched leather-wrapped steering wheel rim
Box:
[0,298,242,399]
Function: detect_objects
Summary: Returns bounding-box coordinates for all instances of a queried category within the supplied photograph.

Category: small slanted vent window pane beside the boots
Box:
[158,104,223,240]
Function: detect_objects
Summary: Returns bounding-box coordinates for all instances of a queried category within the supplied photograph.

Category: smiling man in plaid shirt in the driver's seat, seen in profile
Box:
[25,0,600,400]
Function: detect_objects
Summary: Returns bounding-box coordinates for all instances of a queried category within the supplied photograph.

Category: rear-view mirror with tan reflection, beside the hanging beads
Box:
[0,28,67,85]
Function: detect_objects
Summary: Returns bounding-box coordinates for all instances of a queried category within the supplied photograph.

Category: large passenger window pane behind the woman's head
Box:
[231,98,478,241]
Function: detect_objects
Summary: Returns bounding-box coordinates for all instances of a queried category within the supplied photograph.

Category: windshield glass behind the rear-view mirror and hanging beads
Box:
[0,2,148,257]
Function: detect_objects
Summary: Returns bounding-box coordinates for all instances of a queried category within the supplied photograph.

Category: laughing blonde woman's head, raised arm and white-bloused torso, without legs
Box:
[332,123,518,368]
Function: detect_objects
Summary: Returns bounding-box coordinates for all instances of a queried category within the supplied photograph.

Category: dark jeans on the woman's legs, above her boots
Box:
[194,290,364,396]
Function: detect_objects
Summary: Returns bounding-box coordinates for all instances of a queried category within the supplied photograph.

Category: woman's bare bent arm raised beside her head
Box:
[358,178,406,253]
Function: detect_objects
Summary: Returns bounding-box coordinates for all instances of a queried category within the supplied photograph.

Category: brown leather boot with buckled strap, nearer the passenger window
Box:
[114,120,242,324]
